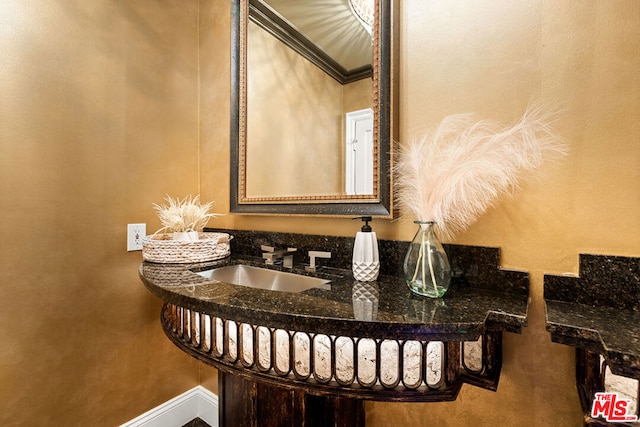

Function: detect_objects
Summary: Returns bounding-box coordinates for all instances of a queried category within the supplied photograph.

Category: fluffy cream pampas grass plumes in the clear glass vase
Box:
[395,107,567,239]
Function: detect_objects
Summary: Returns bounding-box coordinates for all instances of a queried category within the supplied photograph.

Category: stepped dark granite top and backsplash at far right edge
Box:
[544,254,640,380]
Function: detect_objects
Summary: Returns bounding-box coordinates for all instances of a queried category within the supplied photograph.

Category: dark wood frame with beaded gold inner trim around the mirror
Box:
[230,0,398,218]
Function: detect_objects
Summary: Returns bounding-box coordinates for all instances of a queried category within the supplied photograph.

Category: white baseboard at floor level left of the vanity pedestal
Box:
[120,385,218,427]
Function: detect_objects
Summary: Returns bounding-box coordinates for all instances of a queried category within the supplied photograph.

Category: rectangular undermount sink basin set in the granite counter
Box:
[197,264,331,292]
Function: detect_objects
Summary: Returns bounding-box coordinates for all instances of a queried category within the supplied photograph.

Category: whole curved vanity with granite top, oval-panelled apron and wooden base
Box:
[139,230,529,426]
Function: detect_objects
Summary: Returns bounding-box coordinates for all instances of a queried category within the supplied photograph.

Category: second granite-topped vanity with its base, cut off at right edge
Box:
[544,254,640,427]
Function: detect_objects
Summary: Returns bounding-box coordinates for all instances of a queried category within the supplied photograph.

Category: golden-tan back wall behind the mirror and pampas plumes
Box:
[202,0,640,427]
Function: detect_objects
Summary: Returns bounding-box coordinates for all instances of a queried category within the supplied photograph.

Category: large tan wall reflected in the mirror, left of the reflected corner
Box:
[247,23,344,197]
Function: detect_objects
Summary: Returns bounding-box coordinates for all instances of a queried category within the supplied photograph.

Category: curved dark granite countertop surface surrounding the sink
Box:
[139,256,529,341]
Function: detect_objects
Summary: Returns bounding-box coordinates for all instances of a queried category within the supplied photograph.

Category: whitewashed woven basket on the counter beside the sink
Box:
[142,233,233,264]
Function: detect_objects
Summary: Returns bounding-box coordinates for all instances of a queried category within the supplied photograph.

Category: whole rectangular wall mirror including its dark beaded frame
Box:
[230,0,397,217]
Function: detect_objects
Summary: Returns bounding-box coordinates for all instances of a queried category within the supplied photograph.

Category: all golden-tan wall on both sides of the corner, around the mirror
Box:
[0,0,640,427]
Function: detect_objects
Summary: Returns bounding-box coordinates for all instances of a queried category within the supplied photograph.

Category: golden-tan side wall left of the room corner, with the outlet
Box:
[0,0,206,426]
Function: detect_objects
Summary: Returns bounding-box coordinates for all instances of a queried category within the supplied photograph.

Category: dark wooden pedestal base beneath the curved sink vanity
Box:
[218,371,364,427]
